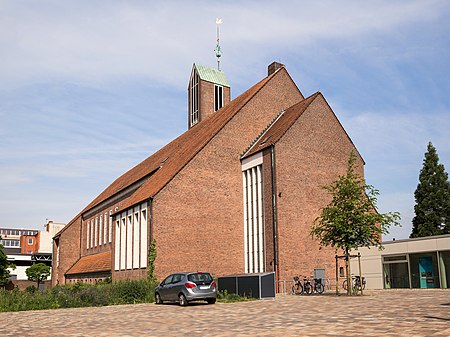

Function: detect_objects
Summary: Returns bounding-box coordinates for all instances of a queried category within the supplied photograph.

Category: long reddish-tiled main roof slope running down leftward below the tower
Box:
[81,69,276,215]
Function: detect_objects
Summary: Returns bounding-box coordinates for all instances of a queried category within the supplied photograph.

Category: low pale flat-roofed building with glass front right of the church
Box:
[351,235,450,289]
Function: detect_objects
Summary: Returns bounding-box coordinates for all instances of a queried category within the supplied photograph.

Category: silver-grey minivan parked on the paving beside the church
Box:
[155,272,217,306]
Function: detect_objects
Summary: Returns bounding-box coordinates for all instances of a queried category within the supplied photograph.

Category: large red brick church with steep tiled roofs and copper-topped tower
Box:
[52,62,364,284]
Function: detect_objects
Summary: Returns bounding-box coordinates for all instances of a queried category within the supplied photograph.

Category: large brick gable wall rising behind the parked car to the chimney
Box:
[153,70,302,279]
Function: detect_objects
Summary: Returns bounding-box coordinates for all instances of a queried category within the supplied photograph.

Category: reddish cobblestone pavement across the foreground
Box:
[0,289,450,337]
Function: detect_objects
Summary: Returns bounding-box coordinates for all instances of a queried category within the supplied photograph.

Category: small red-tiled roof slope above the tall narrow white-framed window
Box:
[241,92,320,158]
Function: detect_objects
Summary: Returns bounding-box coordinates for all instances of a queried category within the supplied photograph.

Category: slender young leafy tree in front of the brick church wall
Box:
[311,151,400,294]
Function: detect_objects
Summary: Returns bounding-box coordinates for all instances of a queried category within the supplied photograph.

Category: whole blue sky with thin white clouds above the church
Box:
[0,0,450,240]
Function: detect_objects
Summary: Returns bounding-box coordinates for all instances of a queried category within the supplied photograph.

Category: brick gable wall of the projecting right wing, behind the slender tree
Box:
[275,96,364,280]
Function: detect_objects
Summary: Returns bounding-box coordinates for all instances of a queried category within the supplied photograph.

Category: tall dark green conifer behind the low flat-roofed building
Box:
[410,142,450,238]
